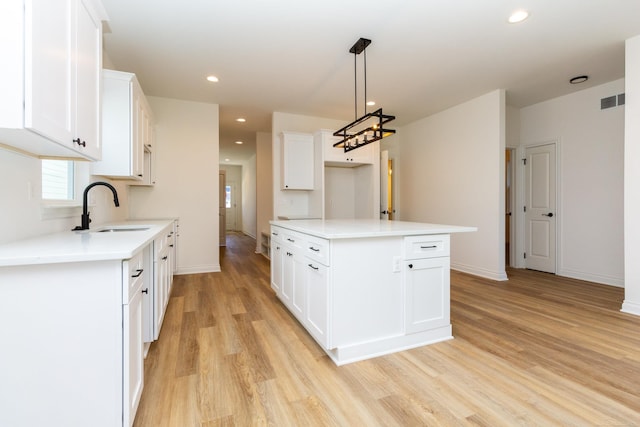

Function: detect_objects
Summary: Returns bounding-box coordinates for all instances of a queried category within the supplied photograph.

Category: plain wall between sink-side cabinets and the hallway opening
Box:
[130,96,220,274]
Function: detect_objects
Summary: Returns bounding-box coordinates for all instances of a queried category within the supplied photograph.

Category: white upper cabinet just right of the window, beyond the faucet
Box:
[91,70,154,185]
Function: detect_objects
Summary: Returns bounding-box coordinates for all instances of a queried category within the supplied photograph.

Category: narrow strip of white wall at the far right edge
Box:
[622,36,640,315]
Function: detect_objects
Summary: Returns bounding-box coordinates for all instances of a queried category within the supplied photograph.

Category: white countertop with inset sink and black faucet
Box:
[0,219,173,267]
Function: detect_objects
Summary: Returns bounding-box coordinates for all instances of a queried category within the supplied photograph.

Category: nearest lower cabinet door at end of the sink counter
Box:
[122,276,144,426]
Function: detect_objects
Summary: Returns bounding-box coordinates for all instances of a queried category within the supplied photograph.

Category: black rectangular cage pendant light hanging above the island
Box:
[333,38,396,153]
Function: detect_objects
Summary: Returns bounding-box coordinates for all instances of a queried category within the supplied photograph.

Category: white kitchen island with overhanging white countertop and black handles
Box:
[271,220,476,365]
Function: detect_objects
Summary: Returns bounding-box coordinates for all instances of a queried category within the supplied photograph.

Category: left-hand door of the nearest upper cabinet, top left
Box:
[24,0,77,147]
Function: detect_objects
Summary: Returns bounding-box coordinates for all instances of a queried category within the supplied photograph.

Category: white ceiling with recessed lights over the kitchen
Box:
[102,0,640,163]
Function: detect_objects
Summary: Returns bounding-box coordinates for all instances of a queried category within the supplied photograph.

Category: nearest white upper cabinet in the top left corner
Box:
[0,0,102,160]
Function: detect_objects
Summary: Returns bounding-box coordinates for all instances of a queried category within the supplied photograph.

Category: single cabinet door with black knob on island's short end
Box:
[404,257,450,333]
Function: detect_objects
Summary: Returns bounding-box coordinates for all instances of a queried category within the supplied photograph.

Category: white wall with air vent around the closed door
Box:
[518,80,625,286]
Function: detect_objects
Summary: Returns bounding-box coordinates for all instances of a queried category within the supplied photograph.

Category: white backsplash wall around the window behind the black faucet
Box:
[0,148,128,243]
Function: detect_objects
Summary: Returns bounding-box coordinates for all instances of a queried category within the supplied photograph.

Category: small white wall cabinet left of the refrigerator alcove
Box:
[280,132,314,190]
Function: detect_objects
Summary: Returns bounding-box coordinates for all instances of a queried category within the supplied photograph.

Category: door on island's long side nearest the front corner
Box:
[304,260,331,349]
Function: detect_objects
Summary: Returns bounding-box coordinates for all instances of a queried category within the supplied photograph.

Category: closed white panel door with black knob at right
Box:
[524,144,557,273]
